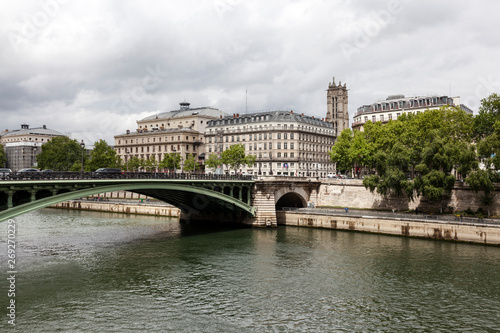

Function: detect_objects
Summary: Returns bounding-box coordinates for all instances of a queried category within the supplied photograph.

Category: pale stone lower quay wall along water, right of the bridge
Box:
[276,210,500,245]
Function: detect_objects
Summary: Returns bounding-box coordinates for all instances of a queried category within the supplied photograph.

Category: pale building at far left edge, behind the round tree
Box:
[0,124,64,171]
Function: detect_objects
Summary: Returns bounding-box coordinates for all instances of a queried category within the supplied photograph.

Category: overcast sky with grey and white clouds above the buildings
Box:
[0,0,500,145]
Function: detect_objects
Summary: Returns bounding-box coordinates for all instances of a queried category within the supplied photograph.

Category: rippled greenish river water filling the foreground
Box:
[0,209,500,332]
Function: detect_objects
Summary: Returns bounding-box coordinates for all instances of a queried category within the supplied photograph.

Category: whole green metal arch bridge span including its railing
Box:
[0,172,256,222]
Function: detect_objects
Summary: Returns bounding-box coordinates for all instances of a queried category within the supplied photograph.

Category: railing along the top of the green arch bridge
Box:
[0,171,253,181]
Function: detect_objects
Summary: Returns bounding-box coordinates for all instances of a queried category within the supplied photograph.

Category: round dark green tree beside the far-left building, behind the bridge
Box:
[37,136,86,171]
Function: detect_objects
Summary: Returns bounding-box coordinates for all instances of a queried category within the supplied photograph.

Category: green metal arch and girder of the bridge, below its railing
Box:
[0,179,256,222]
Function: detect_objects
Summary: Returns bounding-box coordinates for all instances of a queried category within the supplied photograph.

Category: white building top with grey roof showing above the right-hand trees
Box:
[352,95,472,131]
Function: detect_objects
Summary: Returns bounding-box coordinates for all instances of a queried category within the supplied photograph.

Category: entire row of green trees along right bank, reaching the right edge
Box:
[330,94,500,214]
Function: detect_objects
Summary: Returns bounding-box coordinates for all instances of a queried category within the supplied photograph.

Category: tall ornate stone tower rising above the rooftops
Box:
[326,77,349,136]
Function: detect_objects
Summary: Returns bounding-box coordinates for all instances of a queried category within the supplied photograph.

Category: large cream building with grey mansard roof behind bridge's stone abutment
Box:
[205,110,336,177]
